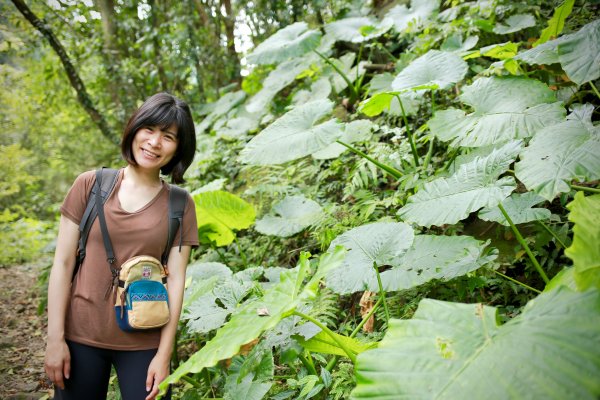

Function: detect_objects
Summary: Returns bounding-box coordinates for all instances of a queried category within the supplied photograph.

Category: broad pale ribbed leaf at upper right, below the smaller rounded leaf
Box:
[428,77,565,147]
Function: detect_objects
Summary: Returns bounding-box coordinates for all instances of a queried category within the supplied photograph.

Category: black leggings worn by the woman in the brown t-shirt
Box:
[54,341,171,400]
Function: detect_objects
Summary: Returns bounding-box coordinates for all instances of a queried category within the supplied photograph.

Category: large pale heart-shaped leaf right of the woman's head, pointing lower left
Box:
[240,100,343,165]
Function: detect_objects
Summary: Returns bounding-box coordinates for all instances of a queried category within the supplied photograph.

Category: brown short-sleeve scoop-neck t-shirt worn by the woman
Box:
[60,169,198,350]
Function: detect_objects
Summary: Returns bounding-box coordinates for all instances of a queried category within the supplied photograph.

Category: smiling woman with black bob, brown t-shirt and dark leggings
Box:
[45,93,198,400]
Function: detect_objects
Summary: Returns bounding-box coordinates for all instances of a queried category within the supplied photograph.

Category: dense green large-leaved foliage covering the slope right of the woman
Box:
[0,0,600,400]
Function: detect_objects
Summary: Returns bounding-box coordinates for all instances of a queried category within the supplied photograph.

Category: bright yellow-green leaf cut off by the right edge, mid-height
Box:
[565,192,600,290]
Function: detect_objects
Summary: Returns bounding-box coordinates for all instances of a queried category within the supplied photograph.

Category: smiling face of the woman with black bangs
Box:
[131,125,179,171]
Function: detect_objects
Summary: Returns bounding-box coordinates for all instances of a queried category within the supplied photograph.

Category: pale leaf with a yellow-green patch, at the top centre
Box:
[325,17,392,43]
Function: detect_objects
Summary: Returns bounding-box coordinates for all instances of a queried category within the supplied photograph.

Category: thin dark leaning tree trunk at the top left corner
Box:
[11,0,119,144]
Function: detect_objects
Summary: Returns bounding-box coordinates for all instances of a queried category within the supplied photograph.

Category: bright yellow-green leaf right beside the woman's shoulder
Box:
[193,190,256,246]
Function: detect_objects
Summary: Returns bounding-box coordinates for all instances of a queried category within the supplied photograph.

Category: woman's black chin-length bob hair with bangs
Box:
[121,93,196,183]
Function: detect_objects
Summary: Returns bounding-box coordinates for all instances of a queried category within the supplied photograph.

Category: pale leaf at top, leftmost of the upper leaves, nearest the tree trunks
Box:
[247,22,321,64]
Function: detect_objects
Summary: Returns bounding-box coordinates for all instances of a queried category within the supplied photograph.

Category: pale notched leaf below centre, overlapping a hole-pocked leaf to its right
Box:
[325,222,414,294]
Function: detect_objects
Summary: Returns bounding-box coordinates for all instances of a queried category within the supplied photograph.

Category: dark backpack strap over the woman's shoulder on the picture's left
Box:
[73,168,119,278]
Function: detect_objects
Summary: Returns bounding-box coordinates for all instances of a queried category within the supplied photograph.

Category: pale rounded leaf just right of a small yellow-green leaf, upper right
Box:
[392,50,469,91]
